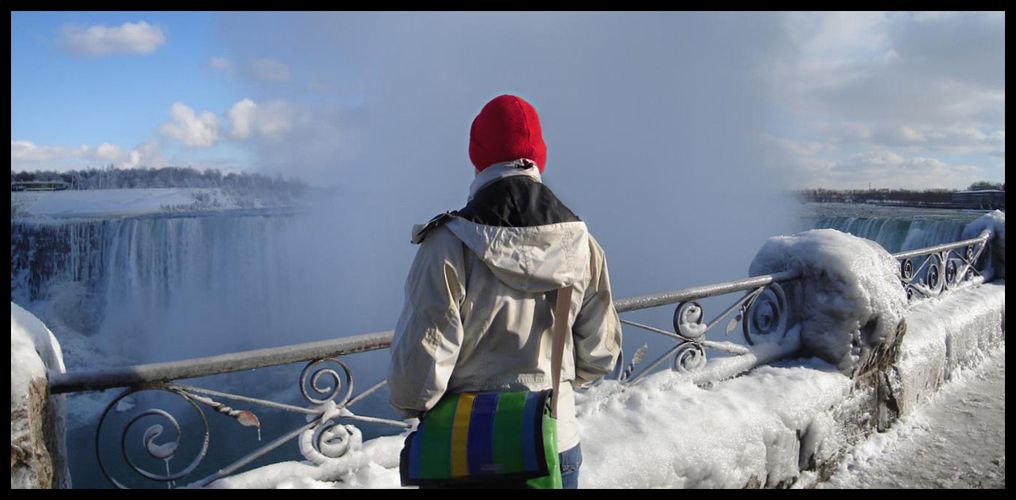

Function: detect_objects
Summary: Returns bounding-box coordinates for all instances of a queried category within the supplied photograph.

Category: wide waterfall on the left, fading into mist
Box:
[11,213,353,362]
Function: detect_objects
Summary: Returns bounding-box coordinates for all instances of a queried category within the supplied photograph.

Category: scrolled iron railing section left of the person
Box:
[50,331,410,488]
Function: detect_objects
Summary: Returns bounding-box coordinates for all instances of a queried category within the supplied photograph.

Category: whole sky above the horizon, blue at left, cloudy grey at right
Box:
[11,11,1005,192]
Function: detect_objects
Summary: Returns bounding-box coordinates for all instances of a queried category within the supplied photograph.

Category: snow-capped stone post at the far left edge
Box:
[10,302,70,489]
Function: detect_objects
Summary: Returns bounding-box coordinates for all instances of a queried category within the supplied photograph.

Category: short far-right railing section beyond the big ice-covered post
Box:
[892,230,992,301]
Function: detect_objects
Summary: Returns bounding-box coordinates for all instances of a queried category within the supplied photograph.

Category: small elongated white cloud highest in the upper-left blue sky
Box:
[60,20,166,57]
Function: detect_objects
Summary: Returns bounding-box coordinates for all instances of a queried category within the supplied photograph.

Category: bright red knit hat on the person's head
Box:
[469,95,547,173]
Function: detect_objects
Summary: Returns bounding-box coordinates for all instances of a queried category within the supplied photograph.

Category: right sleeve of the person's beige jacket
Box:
[572,235,621,386]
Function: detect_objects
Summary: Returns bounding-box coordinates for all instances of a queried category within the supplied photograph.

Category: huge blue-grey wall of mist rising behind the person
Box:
[198,12,798,371]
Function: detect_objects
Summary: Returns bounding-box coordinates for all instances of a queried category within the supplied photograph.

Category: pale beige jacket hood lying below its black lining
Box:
[446,215,589,293]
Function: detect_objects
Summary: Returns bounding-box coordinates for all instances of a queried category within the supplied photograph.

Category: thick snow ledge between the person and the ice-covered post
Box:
[576,359,851,488]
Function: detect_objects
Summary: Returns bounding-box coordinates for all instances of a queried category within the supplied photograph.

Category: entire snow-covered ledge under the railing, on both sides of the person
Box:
[211,282,1005,488]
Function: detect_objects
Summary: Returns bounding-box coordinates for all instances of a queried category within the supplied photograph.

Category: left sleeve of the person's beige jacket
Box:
[388,228,465,419]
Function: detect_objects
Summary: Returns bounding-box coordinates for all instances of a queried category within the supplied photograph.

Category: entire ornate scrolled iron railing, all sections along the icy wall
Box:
[50,232,990,488]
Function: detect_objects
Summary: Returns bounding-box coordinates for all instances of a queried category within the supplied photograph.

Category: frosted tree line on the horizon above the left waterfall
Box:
[10,166,307,196]
